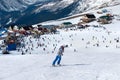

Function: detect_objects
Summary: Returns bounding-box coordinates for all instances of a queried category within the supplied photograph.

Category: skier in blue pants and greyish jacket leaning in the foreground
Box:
[52,45,68,66]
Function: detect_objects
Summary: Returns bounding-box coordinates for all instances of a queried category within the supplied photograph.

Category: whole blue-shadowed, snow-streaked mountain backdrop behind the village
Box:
[0,0,116,27]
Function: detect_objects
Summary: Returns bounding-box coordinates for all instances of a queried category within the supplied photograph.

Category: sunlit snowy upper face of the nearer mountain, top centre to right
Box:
[34,0,119,15]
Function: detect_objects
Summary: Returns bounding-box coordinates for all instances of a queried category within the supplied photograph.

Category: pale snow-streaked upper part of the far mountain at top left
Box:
[0,0,46,12]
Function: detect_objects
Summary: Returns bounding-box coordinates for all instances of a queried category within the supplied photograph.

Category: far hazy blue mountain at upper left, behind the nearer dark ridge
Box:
[0,0,50,26]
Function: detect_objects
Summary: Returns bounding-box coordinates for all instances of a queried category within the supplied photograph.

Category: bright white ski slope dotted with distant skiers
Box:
[0,5,120,80]
